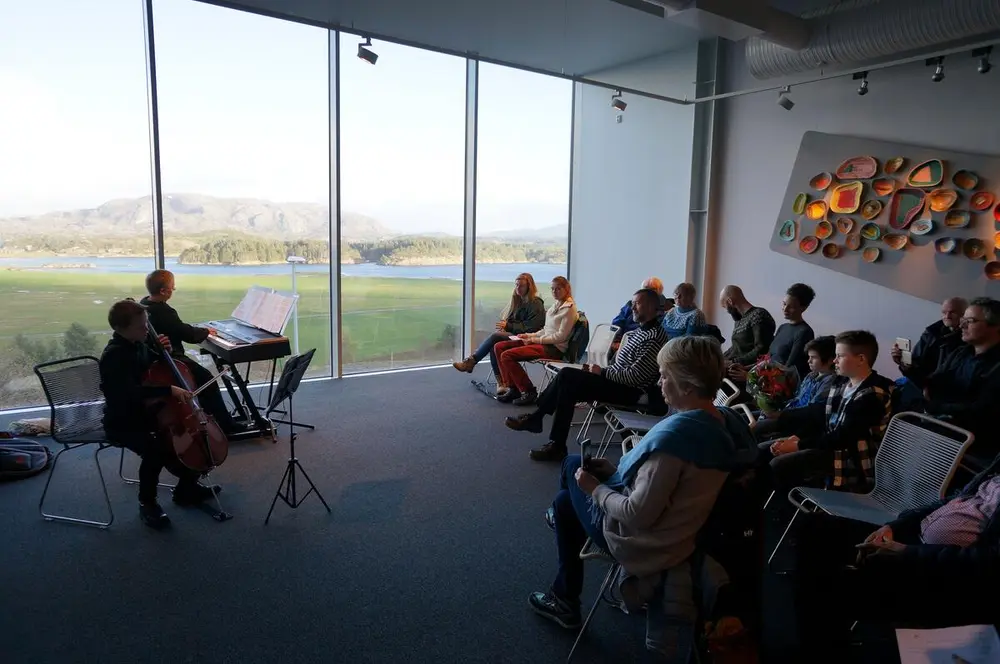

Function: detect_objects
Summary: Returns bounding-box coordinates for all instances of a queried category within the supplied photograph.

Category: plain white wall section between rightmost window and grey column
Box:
[569,48,697,325]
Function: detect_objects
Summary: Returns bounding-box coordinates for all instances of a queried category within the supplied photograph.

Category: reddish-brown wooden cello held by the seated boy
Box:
[143,325,229,521]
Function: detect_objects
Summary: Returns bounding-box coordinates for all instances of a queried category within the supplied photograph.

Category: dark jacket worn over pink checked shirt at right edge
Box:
[889,456,1000,582]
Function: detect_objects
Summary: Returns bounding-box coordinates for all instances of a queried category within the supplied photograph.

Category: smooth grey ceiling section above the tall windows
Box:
[195,0,709,76]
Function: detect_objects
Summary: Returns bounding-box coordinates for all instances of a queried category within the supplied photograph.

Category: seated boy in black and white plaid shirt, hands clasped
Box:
[761,330,894,494]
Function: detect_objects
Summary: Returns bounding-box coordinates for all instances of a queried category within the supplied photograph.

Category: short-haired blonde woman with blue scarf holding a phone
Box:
[529,337,755,629]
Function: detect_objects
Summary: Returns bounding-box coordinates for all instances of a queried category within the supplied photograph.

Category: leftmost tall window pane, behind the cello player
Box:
[0,0,153,408]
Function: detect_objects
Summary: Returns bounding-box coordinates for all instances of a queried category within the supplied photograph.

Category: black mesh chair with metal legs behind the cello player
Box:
[35,356,115,528]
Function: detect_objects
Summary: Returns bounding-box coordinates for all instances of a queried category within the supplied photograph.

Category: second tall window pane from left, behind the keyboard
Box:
[154,0,331,379]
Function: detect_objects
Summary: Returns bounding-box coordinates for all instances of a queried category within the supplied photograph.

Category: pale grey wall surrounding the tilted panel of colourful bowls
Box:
[705,45,1000,377]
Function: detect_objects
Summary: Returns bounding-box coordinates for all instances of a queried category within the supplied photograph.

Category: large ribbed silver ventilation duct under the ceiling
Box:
[746,0,1000,79]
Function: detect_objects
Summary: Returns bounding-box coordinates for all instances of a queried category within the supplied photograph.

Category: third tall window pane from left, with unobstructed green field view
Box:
[340,39,466,373]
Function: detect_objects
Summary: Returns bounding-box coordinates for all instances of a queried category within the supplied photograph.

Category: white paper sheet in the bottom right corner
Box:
[896,625,1000,664]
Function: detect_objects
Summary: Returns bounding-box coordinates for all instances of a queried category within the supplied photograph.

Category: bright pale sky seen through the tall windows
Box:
[0,0,572,235]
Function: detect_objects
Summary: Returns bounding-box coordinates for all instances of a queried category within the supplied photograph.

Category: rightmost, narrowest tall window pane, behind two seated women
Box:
[474,63,573,343]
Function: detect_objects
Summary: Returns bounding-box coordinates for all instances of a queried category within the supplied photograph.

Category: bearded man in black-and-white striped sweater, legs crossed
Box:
[506,288,667,461]
